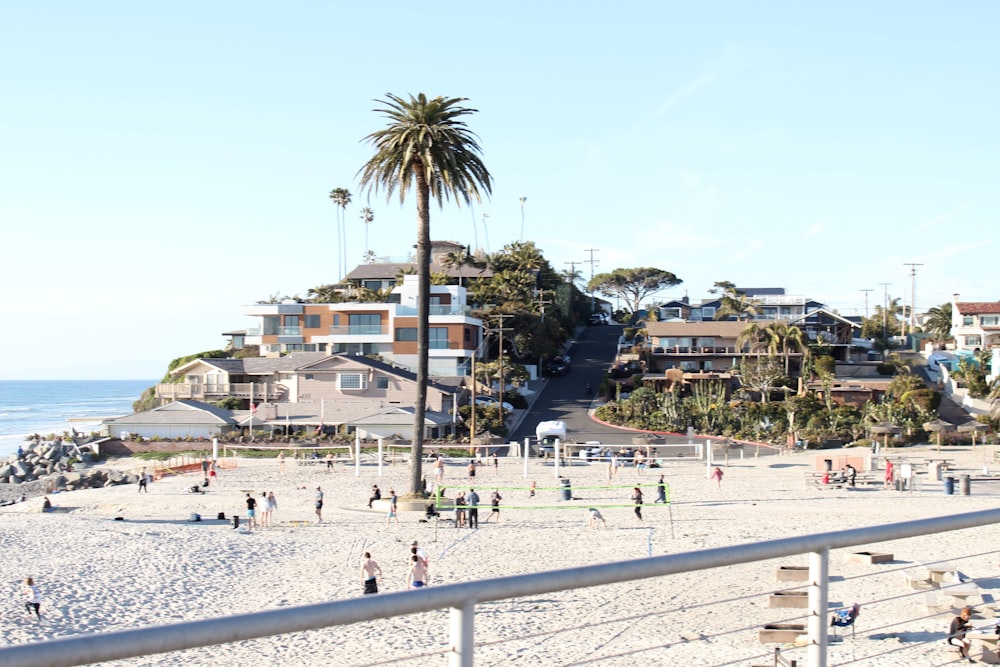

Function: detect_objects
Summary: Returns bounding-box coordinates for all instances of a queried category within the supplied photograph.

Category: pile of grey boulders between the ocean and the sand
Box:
[0,441,138,498]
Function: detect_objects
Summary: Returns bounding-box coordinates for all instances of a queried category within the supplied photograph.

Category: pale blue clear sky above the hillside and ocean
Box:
[0,0,1000,379]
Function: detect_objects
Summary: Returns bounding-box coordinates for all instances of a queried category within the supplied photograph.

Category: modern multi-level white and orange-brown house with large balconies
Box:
[236,275,483,376]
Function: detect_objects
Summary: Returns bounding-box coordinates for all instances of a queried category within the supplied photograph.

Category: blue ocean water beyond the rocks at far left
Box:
[0,380,158,460]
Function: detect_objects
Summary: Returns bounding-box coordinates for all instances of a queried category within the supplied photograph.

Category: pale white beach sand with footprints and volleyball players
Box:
[0,447,1000,667]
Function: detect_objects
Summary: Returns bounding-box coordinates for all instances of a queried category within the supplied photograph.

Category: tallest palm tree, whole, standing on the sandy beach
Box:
[358,93,493,494]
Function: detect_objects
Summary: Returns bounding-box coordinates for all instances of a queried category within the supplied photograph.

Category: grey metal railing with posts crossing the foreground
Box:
[0,509,1000,667]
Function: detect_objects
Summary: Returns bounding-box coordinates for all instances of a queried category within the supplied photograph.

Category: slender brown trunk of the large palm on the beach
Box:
[410,171,431,495]
